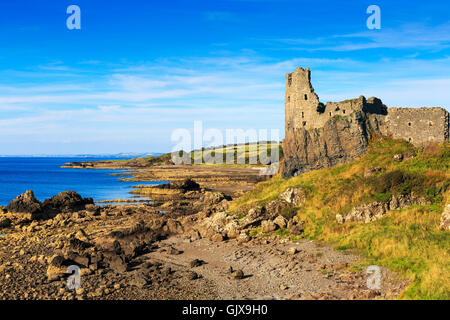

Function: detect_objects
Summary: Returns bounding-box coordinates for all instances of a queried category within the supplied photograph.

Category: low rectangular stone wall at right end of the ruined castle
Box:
[382,108,449,145]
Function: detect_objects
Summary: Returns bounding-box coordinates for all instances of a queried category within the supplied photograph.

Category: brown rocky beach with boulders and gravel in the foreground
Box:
[0,170,406,300]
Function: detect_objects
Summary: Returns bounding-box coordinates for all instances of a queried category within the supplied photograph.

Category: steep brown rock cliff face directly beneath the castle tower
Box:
[282,111,379,179]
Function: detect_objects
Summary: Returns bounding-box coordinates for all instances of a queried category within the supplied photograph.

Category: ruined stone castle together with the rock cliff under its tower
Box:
[282,68,449,178]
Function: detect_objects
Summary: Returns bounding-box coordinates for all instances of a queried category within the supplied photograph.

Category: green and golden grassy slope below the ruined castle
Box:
[230,138,450,299]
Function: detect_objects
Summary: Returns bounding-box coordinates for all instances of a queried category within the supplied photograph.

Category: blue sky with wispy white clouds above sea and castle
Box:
[0,0,450,154]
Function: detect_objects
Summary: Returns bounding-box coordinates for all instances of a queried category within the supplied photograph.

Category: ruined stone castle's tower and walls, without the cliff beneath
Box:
[285,68,449,145]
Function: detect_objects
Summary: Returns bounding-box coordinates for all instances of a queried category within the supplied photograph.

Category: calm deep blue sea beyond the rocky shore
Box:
[0,157,165,206]
